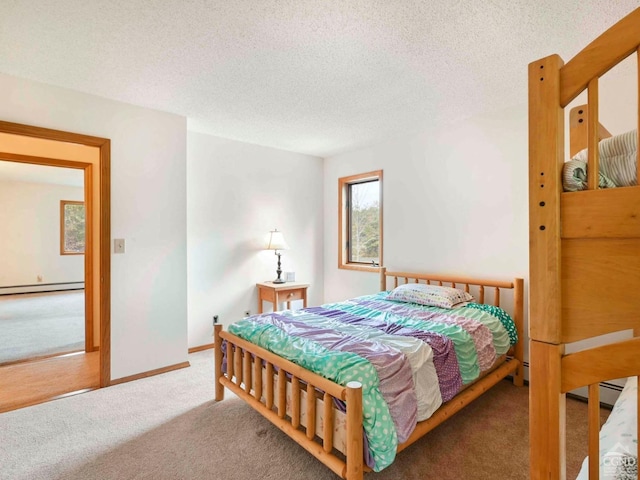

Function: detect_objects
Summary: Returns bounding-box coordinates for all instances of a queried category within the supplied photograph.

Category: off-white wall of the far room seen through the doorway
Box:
[0,178,84,293]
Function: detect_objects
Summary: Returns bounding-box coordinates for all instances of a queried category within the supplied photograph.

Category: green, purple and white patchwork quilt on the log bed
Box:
[224,292,517,471]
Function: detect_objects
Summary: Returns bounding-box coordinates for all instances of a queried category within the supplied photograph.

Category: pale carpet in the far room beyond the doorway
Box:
[0,290,84,364]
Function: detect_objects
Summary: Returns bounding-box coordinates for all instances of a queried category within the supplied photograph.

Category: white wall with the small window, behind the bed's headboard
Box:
[324,107,529,301]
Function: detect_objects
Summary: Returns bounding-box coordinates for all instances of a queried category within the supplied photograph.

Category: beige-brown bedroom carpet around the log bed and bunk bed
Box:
[0,350,608,480]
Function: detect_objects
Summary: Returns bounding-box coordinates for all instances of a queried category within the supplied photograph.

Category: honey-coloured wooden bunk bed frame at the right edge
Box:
[529,5,640,480]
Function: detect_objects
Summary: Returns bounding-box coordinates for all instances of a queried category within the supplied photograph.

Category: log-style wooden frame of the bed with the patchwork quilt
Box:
[214,268,524,480]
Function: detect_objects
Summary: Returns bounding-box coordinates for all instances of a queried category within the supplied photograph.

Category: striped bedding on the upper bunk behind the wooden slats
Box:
[562,130,638,192]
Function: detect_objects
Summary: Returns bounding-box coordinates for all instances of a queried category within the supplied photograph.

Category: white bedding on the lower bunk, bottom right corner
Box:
[578,377,638,480]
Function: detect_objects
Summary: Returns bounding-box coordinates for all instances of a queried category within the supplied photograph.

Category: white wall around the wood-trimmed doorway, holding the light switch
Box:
[0,74,187,379]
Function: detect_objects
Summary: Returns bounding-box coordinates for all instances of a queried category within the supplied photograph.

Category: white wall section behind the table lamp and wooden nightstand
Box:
[187,132,323,347]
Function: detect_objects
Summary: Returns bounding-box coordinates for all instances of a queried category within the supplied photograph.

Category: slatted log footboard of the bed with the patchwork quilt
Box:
[214,325,362,480]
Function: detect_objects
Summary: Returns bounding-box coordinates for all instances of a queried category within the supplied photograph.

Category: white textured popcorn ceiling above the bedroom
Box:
[0,0,639,157]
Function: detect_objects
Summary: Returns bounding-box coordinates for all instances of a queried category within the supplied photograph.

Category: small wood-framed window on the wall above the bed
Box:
[338,170,382,270]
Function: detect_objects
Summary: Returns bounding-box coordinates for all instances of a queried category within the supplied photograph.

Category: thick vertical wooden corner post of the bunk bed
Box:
[529,55,565,480]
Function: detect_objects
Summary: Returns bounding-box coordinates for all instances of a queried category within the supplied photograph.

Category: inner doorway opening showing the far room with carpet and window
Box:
[0,159,87,366]
